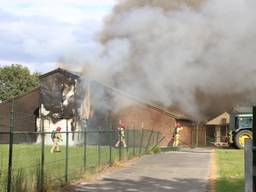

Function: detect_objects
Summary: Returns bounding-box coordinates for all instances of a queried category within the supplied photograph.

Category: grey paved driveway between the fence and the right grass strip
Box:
[67,149,211,192]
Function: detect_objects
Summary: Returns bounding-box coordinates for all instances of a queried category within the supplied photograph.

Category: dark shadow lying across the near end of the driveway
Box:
[63,176,207,192]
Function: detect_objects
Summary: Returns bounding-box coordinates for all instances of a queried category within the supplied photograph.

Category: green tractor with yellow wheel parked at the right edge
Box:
[229,110,253,149]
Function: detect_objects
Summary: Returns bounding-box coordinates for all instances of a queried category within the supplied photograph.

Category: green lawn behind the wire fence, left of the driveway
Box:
[0,144,144,192]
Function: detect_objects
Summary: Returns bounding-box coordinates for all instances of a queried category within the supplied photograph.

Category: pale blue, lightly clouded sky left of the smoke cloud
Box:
[0,0,116,72]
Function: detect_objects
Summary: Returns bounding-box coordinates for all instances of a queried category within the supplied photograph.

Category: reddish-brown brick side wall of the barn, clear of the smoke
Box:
[119,103,205,146]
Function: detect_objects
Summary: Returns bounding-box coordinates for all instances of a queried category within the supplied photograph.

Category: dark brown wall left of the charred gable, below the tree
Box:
[0,88,40,144]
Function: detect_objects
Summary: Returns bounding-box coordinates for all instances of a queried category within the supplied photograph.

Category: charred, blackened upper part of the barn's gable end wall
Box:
[40,69,79,121]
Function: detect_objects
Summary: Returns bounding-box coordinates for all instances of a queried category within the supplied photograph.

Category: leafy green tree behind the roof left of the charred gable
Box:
[0,64,39,101]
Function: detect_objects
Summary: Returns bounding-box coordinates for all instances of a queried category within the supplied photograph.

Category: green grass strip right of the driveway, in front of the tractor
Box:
[216,149,244,192]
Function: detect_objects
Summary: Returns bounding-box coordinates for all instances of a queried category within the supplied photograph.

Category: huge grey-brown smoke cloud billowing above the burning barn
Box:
[60,0,256,120]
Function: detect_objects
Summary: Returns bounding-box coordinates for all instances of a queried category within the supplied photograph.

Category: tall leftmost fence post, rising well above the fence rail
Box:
[7,99,14,192]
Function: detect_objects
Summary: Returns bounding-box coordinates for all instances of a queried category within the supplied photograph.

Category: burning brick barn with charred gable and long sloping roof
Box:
[0,68,206,146]
